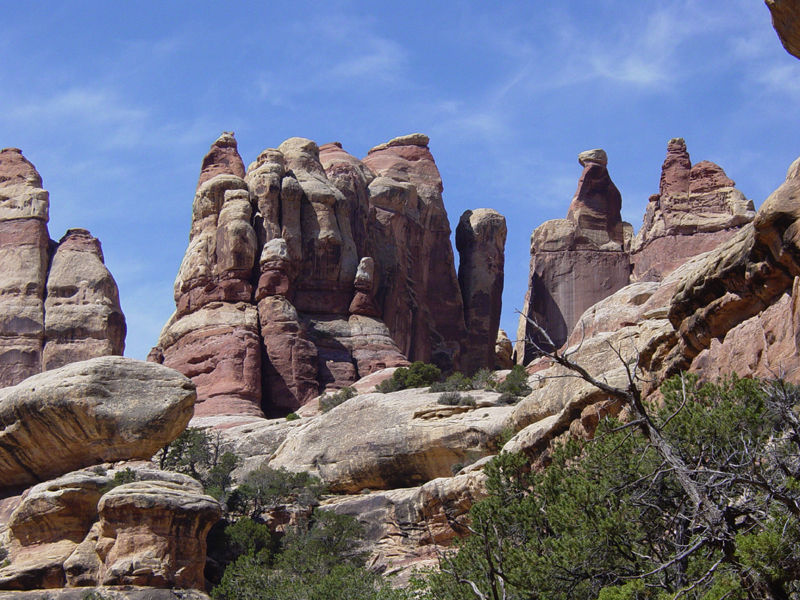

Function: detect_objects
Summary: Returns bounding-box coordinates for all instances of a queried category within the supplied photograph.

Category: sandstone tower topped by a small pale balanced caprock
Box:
[516,149,633,364]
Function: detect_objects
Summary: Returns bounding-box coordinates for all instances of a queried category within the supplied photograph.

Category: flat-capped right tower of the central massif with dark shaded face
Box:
[364,134,466,370]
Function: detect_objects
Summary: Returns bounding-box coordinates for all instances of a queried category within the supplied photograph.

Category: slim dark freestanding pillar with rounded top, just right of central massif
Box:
[456,208,508,375]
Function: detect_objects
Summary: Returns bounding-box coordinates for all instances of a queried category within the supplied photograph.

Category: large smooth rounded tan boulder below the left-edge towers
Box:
[0,356,196,488]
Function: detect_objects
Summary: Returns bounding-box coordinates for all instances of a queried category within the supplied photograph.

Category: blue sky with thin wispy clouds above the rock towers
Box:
[0,0,800,358]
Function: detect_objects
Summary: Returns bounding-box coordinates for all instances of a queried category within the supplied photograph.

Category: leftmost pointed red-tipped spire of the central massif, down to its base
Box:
[159,133,263,416]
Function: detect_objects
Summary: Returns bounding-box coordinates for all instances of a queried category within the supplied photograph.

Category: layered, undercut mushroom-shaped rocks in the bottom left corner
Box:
[0,463,221,590]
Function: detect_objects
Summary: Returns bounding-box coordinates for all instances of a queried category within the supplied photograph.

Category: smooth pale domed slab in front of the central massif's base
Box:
[269,390,512,493]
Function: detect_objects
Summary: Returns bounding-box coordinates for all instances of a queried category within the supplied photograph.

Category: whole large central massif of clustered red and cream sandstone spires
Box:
[156,134,505,418]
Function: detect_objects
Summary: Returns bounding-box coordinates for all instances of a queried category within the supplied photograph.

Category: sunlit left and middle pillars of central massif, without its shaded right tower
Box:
[157,135,418,416]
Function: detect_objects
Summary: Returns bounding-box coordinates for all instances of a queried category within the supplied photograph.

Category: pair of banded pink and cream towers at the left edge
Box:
[0,148,125,387]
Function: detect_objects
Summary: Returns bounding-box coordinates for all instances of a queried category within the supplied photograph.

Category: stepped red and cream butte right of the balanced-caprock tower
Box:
[631,138,755,281]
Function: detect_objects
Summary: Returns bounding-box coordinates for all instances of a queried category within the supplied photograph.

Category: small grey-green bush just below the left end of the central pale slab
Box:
[228,467,325,517]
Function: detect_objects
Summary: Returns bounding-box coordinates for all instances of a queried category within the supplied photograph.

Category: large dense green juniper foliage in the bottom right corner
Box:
[423,376,800,600]
